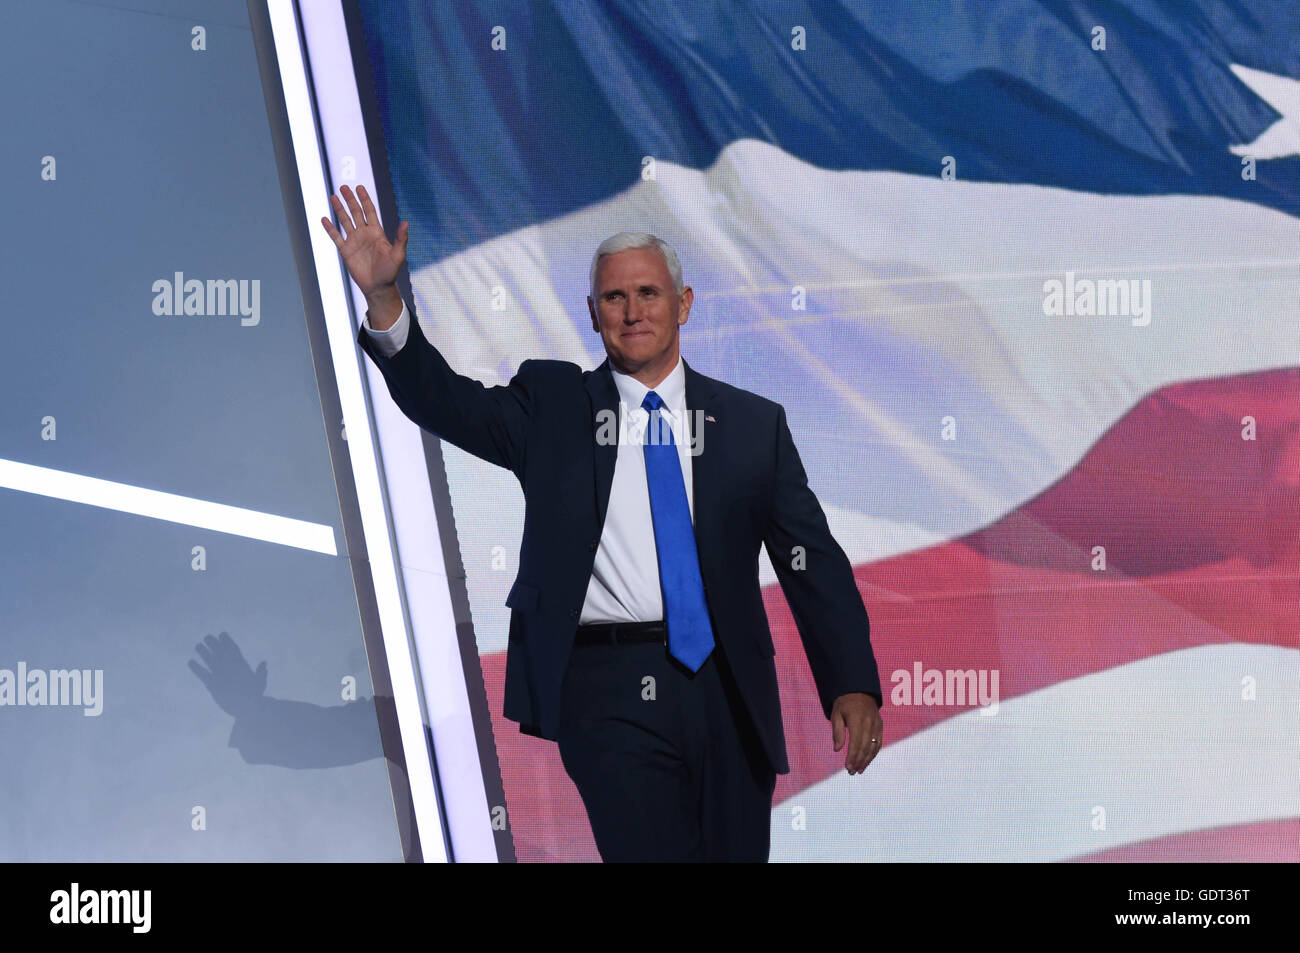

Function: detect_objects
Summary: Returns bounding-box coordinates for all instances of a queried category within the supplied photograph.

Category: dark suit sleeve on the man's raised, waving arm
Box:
[356,295,536,481]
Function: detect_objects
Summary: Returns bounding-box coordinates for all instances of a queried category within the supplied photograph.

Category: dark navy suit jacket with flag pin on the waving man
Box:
[358,306,880,774]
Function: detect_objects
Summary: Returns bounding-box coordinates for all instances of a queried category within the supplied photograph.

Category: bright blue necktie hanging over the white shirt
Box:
[641,390,714,672]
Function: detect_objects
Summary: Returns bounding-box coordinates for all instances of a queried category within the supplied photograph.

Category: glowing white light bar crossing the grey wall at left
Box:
[0,460,338,556]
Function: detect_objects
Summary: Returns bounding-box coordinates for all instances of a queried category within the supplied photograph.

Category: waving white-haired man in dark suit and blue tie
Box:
[321,186,883,861]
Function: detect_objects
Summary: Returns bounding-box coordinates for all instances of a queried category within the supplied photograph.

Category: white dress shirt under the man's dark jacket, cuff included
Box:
[365,302,696,625]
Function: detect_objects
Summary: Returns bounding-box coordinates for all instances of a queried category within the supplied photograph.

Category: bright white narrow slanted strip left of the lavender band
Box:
[267,0,447,862]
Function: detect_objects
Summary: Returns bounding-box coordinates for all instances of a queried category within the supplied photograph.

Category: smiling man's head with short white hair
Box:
[586,248,693,380]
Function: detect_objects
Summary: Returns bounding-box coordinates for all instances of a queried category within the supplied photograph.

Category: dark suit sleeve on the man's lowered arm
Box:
[763,407,881,718]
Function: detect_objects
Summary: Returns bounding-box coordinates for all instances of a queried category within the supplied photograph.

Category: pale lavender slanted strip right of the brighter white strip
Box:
[292,1,497,862]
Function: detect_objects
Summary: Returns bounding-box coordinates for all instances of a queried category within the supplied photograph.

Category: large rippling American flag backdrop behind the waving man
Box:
[363,0,1300,861]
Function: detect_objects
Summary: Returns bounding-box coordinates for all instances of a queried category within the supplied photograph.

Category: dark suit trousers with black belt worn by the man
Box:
[556,631,776,862]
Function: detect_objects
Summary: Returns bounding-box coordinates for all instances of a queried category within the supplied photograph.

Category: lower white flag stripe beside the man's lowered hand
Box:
[771,642,1300,863]
